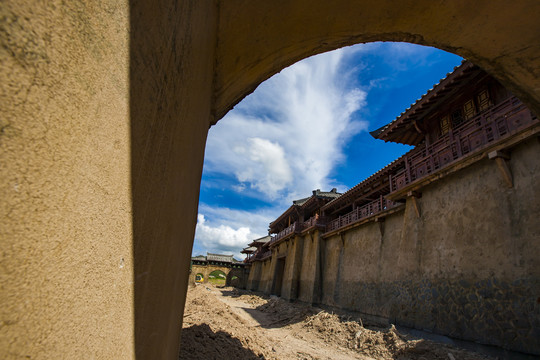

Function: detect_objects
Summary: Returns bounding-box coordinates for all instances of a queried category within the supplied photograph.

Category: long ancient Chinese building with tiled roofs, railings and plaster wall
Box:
[248,61,540,354]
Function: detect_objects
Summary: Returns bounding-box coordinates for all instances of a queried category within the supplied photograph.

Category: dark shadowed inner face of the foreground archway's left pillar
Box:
[130,1,217,359]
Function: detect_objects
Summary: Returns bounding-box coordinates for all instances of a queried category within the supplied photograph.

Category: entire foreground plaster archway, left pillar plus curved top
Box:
[0,0,540,359]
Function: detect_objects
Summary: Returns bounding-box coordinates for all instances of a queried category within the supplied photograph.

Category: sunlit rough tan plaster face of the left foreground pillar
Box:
[0,0,135,359]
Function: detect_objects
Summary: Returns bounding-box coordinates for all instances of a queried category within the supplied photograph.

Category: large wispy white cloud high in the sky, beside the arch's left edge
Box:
[205,49,367,204]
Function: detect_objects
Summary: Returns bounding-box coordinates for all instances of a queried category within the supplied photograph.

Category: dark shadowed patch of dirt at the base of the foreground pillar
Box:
[179,324,264,360]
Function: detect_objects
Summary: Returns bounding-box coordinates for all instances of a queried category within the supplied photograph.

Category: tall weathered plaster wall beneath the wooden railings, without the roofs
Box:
[252,137,540,354]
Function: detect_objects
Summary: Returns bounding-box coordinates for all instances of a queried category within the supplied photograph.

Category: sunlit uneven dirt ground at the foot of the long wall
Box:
[180,284,488,360]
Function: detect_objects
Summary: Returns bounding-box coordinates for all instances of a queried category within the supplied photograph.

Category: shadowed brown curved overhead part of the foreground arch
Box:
[214,0,540,122]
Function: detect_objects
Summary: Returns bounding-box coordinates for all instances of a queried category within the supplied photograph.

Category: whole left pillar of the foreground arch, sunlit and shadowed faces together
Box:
[0,1,217,359]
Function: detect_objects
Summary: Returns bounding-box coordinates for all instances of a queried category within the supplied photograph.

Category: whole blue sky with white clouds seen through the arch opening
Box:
[193,43,462,259]
